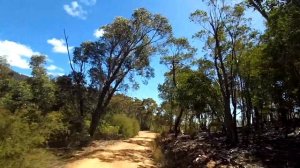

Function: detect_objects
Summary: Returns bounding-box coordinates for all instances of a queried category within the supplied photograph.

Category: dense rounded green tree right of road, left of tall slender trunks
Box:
[176,69,215,131]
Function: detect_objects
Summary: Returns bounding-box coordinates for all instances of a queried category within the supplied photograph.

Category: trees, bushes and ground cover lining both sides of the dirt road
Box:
[0,0,300,168]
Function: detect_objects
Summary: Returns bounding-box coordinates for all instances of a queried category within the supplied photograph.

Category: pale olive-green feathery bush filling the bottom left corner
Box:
[0,109,55,168]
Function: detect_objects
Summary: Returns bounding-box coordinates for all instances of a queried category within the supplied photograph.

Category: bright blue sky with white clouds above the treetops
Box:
[0,0,263,102]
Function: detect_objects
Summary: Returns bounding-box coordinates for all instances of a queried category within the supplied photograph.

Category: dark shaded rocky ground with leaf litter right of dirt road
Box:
[161,131,300,168]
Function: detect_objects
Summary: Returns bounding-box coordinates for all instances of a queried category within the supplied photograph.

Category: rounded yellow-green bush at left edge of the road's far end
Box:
[111,114,140,138]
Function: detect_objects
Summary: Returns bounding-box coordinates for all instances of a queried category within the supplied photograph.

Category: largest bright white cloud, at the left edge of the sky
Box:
[0,40,40,69]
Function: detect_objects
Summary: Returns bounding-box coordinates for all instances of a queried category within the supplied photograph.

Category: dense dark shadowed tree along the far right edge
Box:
[263,1,300,135]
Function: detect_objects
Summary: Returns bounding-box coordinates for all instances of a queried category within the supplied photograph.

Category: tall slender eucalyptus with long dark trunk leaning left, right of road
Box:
[191,1,237,143]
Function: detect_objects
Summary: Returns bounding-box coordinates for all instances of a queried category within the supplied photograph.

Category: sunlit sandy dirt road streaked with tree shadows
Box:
[65,131,156,168]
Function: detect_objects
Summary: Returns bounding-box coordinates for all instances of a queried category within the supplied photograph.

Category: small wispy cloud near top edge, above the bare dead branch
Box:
[64,1,87,19]
